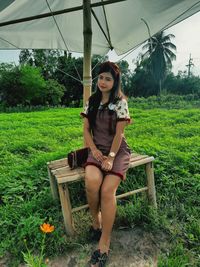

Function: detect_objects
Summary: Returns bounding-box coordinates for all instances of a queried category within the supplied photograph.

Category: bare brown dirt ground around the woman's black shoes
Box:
[0,228,168,267]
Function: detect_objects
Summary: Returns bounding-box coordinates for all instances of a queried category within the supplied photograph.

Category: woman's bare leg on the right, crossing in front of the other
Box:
[99,175,121,253]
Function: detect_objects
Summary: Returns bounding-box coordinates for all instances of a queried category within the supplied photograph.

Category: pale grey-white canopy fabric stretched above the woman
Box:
[0,0,200,55]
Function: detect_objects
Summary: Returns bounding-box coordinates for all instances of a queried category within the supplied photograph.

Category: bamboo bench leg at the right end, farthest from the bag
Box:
[145,162,157,208]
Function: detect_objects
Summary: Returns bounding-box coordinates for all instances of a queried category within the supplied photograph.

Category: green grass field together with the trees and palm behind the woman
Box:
[0,30,200,267]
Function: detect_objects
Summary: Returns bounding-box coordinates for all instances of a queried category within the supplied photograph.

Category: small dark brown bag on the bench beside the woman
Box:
[67,147,89,169]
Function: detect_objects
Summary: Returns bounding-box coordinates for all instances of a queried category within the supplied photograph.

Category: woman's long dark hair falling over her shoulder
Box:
[88,61,123,131]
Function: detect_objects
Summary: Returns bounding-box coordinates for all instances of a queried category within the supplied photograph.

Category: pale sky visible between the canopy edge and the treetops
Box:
[0,12,200,75]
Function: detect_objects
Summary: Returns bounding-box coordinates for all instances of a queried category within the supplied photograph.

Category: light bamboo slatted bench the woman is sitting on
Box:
[47,153,157,235]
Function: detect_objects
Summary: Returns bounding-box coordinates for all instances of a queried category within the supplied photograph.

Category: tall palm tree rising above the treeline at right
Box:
[143,31,176,94]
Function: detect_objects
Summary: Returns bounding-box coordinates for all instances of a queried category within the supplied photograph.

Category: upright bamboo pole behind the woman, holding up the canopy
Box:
[83,0,92,105]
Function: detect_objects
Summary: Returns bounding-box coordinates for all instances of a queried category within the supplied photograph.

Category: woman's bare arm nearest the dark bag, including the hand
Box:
[83,117,104,162]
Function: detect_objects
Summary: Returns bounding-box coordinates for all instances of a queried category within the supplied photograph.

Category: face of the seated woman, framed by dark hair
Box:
[97,72,114,93]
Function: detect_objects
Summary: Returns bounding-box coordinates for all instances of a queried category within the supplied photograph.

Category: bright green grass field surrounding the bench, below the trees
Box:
[0,108,200,267]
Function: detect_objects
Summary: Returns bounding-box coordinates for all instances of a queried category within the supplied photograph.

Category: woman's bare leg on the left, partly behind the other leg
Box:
[85,165,103,229]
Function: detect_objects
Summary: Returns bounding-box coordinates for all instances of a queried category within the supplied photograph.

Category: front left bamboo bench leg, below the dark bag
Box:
[58,184,74,235]
